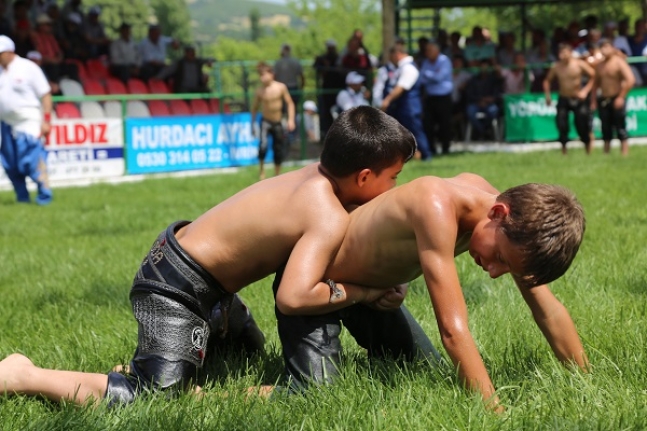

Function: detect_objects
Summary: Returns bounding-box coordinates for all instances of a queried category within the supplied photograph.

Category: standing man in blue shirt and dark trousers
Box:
[420,40,454,154]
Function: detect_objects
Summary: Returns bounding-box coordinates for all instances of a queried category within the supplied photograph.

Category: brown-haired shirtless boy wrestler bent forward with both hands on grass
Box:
[277,174,587,407]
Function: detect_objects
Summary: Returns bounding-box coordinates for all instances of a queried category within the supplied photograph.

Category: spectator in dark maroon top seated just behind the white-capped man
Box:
[33,15,79,82]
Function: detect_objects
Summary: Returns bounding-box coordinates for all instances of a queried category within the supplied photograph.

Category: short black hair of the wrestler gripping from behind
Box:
[320,106,416,178]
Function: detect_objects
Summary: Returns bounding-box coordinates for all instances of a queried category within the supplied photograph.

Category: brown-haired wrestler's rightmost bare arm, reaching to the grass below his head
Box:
[519,285,589,371]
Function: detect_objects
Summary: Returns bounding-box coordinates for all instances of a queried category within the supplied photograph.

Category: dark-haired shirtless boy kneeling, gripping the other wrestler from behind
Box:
[0,107,416,403]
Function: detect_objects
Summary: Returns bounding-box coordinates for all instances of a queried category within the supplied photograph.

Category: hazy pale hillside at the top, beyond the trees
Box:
[187,0,300,43]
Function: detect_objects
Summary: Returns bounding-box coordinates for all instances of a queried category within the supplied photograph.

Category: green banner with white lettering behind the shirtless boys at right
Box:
[504,88,647,142]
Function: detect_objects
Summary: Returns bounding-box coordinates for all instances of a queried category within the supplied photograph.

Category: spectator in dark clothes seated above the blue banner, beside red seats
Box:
[158,46,213,93]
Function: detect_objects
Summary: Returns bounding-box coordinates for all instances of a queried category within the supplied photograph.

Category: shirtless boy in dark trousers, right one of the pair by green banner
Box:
[591,39,636,156]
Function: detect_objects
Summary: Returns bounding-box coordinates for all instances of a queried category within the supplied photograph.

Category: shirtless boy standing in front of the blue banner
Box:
[251,62,295,180]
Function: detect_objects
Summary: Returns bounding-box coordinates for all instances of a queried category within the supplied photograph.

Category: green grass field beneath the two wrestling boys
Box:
[0,146,647,431]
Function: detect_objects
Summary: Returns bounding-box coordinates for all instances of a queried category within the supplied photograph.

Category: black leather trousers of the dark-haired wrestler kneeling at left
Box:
[106,221,265,404]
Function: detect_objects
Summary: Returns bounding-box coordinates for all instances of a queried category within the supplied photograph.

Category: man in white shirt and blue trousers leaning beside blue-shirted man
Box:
[380,43,431,160]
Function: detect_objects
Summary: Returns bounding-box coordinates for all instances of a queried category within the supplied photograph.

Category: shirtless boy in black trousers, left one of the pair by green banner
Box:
[543,43,595,154]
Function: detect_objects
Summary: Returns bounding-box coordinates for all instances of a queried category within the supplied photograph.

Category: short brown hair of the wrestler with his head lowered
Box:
[497,183,586,287]
